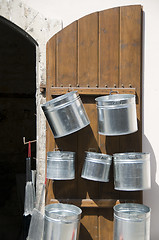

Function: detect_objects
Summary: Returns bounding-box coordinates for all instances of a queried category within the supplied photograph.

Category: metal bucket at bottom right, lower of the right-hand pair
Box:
[114,203,150,240]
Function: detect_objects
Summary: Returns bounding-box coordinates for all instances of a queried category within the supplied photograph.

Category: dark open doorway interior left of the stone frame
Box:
[0,17,36,240]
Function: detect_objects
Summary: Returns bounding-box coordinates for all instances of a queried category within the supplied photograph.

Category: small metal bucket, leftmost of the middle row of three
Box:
[47,151,75,180]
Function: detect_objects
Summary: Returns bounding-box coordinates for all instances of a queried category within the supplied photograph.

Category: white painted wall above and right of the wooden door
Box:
[23,0,159,240]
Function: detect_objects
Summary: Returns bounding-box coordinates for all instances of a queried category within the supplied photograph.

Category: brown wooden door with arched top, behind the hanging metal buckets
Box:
[46,5,142,240]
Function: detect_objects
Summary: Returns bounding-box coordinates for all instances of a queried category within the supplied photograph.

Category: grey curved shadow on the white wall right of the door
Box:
[143,135,159,240]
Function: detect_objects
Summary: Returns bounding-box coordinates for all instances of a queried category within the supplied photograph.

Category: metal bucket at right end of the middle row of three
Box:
[113,152,151,191]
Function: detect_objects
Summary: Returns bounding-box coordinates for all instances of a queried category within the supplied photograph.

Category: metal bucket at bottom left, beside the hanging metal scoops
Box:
[43,203,82,240]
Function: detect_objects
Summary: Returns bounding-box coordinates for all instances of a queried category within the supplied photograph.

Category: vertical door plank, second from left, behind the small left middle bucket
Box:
[51,22,78,198]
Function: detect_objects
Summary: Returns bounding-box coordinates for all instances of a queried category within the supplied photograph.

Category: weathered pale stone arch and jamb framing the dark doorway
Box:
[0,0,62,203]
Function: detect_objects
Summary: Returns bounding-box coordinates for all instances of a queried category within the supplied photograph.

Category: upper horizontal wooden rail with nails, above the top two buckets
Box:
[50,87,135,96]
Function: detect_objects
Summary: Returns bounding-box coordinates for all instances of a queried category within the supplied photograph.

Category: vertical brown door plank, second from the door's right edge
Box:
[98,8,120,240]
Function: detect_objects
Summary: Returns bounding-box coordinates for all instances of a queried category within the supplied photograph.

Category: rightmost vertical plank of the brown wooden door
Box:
[119,5,142,202]
